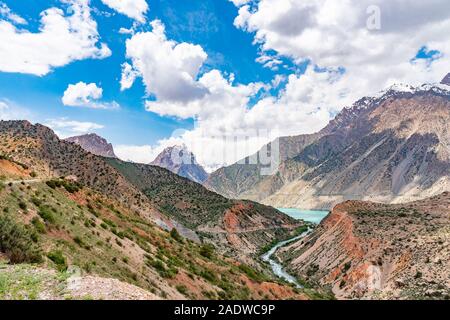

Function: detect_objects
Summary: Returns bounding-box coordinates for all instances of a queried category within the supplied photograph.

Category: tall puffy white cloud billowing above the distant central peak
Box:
[122,20,207,103]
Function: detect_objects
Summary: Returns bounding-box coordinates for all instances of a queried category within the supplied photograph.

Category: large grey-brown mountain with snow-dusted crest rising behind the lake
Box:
[205,74,450,209]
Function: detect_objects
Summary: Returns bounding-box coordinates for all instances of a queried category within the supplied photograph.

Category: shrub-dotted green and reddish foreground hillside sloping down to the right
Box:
[0,174,310,299]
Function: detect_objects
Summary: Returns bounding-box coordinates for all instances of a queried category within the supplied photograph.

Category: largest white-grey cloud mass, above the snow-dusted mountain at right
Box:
[234,0,450,103]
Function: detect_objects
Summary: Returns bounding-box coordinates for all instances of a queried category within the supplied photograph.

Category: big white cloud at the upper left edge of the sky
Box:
[0,0,111,76]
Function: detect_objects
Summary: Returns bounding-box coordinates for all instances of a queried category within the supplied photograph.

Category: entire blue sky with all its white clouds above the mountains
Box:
[0,0,450,170]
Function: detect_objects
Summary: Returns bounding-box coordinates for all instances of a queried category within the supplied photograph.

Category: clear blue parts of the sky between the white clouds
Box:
[0,0,286,144]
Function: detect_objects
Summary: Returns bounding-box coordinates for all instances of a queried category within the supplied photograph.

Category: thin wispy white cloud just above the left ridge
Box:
[44,118,104,139]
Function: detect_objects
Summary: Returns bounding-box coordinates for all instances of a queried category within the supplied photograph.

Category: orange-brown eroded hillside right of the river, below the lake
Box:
[279,192,450,299]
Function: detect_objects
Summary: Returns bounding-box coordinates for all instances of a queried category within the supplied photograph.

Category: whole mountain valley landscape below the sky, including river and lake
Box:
[0,75,450,300]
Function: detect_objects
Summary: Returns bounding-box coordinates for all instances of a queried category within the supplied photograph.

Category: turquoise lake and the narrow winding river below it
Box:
[261,209,329,288]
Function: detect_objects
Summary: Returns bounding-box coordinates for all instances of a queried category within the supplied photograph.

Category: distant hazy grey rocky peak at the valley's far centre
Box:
[150,146,208,183]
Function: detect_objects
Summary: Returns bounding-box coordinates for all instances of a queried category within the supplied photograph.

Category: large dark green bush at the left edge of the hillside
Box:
[0,216,42,263]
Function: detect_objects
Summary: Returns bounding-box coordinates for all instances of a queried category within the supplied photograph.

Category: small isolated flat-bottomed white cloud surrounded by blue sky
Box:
[62,81,119,109]
